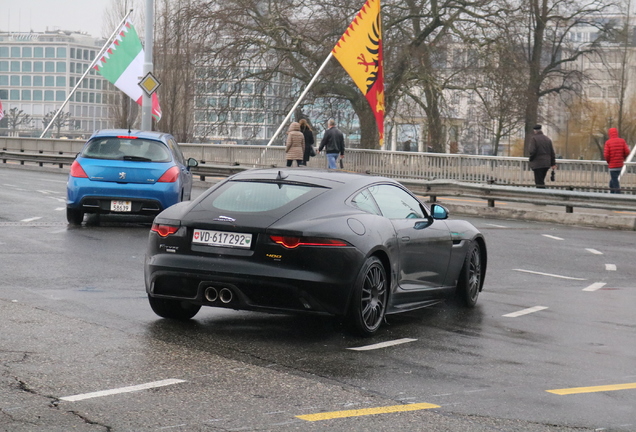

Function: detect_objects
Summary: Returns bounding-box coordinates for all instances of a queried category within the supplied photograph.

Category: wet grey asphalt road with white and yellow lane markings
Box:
[0,167,636,431]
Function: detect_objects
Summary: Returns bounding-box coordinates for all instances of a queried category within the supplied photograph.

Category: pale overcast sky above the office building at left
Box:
[0,0,115,37]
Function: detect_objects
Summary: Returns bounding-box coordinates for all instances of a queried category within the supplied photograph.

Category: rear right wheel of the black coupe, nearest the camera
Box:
[348,257,389,337]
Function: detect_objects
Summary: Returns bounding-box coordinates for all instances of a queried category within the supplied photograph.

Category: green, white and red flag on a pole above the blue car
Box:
[93,21,161,121]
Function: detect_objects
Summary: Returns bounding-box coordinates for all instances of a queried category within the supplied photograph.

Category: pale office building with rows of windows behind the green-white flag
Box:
[0,31,116,138]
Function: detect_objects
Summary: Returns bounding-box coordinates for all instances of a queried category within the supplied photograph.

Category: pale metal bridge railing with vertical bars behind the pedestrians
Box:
[0,137,636,189]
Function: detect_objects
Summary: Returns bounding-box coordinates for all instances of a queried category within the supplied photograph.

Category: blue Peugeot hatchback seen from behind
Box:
[66,129,197,225]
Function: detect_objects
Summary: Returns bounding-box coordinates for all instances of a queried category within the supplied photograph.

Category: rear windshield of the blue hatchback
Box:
[82,137,172,162]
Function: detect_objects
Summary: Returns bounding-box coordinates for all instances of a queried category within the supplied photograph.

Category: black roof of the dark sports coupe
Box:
[230,168,397,189]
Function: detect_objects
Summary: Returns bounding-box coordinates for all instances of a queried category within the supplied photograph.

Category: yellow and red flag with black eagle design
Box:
[331,0,384,146]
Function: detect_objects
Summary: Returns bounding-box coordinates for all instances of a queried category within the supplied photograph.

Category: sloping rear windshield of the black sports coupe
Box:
[201,181,316,213]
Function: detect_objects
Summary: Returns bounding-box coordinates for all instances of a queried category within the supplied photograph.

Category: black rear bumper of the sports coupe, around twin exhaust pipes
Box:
[145,254,362,316]
